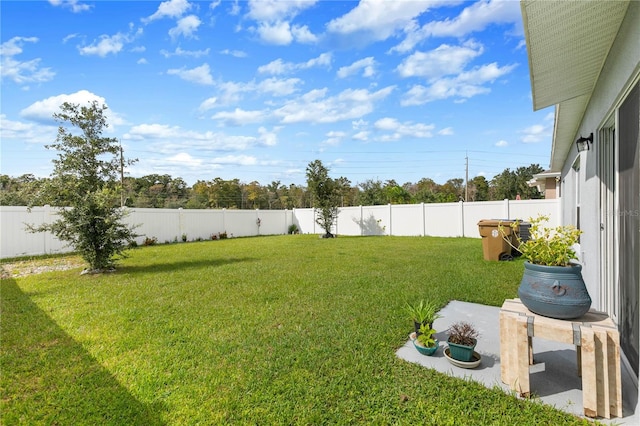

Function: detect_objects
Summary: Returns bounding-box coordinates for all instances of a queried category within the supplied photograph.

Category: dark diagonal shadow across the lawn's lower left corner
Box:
[0,279,167,425]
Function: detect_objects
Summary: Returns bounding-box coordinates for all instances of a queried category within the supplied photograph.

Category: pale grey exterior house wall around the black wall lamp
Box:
[562,1,640,309]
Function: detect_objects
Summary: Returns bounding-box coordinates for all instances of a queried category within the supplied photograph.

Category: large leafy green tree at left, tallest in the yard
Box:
[31,101,135,272]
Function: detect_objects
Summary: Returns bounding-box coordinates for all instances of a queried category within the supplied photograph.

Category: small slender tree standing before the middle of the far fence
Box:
[307,160,340,237]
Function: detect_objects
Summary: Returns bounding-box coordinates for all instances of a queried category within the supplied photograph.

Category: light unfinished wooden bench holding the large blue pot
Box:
[500,299,622,419]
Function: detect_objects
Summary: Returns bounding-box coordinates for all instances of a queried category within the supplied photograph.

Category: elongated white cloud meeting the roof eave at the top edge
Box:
[392,0,522,53]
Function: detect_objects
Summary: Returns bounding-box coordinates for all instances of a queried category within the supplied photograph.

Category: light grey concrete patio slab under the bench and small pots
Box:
[396,301,640,425]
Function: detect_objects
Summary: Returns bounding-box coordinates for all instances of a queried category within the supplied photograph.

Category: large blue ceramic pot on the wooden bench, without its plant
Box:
[518,262,591,319]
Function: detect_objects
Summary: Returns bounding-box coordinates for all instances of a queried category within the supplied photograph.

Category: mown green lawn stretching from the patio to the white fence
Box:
[0,235,585,425]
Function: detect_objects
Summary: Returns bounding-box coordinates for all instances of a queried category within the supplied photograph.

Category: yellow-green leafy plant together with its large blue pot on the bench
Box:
[500,215,591,319]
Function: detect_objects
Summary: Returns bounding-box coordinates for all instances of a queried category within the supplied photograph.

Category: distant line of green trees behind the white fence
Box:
[0,160,544,210]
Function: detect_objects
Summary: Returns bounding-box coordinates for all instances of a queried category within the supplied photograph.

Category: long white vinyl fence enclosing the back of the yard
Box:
[0,199,562,258]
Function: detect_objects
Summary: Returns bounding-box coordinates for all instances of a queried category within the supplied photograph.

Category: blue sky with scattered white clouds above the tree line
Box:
[0,0,553,185]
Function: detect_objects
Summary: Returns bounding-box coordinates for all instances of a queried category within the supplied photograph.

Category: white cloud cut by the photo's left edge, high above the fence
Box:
[0,37,56,84]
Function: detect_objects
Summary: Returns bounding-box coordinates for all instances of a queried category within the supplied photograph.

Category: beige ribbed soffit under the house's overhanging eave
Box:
[520,0,629,171]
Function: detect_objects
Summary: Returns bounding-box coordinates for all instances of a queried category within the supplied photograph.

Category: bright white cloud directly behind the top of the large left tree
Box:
[20,90,124,127]
